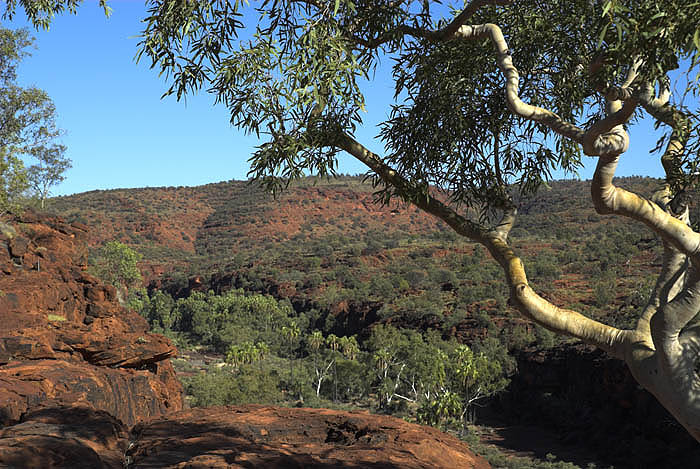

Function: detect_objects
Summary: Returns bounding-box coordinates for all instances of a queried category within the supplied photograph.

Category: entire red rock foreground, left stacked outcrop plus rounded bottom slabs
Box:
[0,211,490,469]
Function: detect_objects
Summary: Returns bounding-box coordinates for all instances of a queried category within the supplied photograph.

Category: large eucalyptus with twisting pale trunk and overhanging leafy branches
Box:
[138,0,700,440]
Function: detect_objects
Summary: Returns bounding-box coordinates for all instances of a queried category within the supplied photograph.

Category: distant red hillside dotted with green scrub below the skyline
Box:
[50,177,658,334]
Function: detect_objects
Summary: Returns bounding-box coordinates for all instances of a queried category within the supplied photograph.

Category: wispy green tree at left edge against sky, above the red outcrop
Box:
[0,28,71,212]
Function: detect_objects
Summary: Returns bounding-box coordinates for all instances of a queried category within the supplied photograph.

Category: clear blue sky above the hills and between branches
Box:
[2,0,662,195]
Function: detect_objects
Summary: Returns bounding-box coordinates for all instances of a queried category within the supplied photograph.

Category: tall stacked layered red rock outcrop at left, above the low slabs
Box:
[0,212,182,425]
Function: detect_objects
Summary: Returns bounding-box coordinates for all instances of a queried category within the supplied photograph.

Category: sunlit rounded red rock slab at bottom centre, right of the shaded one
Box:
[127,405,490,469]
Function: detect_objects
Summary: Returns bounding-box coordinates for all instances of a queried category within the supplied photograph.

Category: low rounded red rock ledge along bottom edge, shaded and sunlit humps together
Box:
[0,405,490,469]
